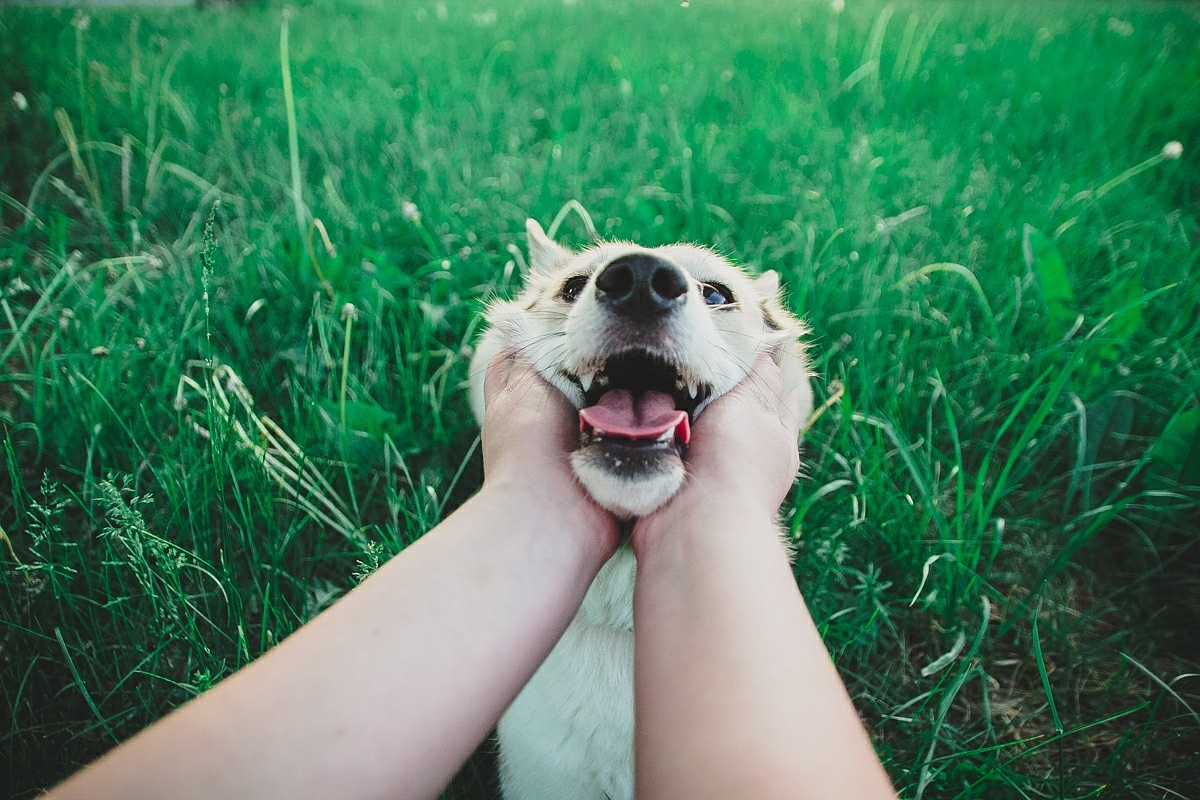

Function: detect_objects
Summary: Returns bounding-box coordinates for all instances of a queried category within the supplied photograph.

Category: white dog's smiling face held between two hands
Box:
[470,219,811,518]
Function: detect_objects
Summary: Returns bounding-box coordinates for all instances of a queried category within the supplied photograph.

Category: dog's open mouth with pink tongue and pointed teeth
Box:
[576,351,712,452]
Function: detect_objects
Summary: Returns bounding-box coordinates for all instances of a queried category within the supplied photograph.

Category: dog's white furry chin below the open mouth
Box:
[571,440,685,519]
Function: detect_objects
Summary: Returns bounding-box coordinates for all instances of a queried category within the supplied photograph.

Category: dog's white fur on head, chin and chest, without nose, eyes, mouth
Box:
[470,219,812,800]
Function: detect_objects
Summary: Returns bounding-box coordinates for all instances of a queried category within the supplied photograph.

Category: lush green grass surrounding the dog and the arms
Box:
[0,0,1200,799]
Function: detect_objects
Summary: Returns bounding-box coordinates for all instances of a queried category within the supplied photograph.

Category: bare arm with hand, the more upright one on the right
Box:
[632,359,895,800]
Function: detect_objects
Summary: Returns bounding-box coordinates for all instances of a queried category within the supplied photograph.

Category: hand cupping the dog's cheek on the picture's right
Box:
[632,354,803,551]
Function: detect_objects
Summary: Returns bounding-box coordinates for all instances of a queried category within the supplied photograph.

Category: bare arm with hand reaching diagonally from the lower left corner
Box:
[49,357,618,800]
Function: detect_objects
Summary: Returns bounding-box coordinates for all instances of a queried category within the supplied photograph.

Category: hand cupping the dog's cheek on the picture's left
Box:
[482,350,617,541]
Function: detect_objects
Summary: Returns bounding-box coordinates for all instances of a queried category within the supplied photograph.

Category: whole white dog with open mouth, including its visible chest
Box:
[470,219,812,800]
